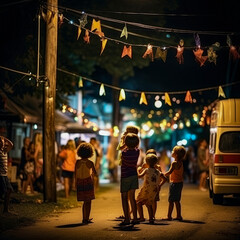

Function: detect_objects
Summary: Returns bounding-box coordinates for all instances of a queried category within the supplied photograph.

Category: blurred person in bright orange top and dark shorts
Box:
[59,139,76,198]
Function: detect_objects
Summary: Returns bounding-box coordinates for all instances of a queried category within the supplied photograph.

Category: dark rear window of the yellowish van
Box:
[219,131,240,153]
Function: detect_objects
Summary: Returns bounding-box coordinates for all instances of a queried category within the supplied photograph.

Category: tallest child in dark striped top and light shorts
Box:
[120,133,139,226]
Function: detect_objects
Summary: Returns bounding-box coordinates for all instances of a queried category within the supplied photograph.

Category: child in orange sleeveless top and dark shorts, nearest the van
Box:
[164,146,186,221]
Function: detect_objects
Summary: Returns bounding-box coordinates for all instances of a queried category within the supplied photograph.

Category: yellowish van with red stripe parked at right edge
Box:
[209,99,240,204]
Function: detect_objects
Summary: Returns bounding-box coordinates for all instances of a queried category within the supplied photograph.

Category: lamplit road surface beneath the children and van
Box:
[0,183,240,240]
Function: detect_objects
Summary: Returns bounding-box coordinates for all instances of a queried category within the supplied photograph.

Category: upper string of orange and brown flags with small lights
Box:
[42,6,240,64]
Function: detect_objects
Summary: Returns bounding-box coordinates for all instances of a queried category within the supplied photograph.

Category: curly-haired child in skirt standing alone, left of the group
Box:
[75,143,97,224]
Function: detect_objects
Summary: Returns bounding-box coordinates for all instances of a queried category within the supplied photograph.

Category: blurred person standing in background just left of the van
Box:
[197,139,208,191]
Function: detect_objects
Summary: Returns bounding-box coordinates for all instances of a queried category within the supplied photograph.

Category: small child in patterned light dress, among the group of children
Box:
[137,152,166,224]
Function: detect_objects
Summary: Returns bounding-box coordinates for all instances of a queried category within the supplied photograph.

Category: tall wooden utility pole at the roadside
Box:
[43,0,58,202]
